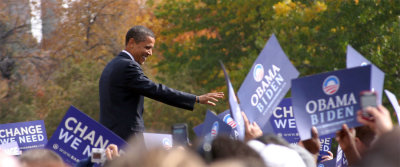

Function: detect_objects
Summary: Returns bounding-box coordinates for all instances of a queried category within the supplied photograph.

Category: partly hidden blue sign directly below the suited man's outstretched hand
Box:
[201,110,232,138]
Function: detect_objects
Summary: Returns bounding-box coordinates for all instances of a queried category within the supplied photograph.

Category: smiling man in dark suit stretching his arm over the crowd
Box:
[99,26,224,140]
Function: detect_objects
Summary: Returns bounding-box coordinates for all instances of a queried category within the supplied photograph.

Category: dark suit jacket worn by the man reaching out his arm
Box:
[99,52,196,140]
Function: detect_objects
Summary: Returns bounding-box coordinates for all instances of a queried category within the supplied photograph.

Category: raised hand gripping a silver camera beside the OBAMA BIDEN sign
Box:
[357,105,393,137]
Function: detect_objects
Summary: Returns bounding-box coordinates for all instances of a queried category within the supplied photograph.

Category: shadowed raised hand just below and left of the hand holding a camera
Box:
[336,124,361,165]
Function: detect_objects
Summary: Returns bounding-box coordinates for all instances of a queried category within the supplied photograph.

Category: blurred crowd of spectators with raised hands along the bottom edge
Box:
[0,106,400,167]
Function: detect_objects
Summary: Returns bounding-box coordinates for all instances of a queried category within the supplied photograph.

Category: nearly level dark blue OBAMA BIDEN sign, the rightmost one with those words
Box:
[292,65,373,140]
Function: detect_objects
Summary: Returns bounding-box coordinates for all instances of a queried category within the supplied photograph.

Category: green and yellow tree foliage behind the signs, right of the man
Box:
[156,0,400,128]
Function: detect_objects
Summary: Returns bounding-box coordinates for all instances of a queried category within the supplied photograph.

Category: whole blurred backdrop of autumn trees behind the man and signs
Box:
[0,0,400,138]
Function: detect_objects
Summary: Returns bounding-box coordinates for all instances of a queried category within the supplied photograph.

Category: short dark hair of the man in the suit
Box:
[125,26,155,45]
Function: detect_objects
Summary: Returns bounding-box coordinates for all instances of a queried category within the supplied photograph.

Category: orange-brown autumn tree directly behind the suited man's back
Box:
[37,0,166,136]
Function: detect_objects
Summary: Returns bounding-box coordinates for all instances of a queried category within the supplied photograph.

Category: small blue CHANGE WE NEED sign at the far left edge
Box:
[0,120,47,151]
